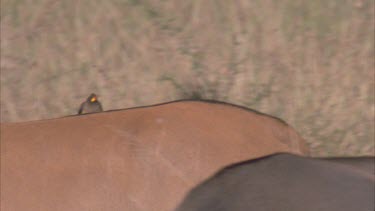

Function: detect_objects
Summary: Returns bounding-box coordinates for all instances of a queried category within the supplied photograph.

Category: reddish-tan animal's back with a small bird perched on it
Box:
[0,101,308,211]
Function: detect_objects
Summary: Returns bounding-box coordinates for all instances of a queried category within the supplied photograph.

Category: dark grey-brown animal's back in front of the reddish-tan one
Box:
[177,154,375,211]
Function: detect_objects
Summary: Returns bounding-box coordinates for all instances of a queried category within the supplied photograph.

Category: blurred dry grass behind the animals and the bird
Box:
[0,0,375,156]
